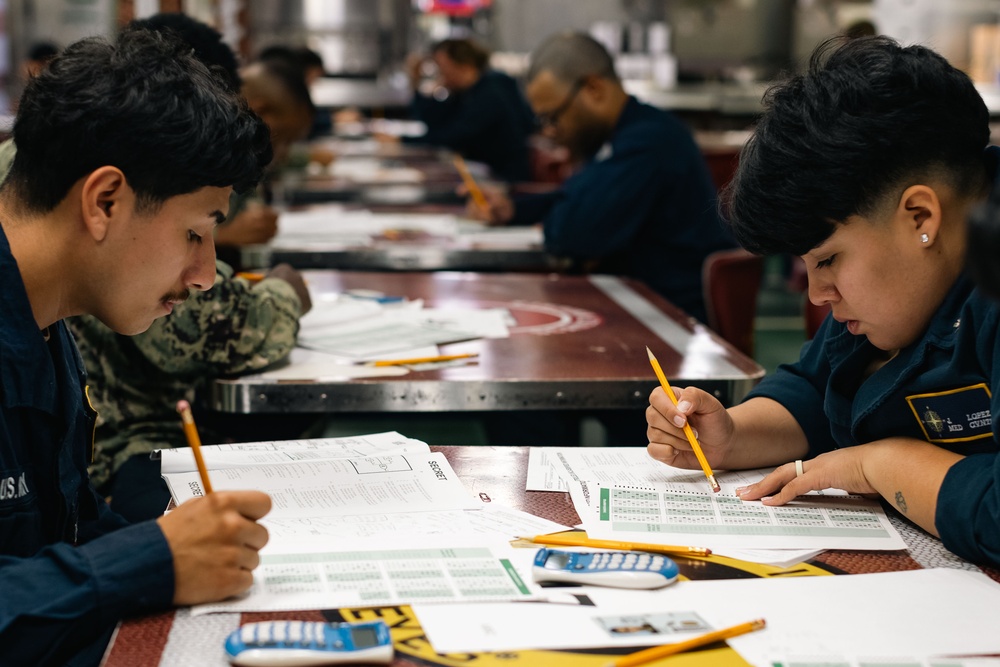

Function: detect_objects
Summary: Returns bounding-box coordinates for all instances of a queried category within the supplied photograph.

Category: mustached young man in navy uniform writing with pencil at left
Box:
[0,24,271,665]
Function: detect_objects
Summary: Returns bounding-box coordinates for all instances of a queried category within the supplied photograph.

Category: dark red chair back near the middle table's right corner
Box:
[702,248,764,357]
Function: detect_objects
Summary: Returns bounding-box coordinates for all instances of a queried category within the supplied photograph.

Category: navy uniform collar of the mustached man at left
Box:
[0,222,62,414]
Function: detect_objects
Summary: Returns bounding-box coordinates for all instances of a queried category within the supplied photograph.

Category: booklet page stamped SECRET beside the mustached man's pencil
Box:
[163,452,479,520]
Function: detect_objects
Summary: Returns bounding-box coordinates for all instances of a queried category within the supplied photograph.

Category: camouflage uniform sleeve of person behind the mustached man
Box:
[67,262,302,489]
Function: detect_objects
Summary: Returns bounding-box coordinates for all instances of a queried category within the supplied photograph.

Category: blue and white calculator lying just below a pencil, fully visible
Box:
[531,548,680,588]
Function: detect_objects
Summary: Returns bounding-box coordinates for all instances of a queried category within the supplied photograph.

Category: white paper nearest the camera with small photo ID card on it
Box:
[413,569,1000,656]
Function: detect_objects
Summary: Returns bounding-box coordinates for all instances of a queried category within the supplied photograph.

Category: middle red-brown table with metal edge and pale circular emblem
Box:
[208,271,764,414]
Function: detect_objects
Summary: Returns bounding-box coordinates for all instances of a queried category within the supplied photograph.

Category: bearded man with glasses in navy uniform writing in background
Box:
[469,33,734,320]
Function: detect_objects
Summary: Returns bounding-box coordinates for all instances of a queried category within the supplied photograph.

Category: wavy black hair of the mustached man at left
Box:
[2,29,271,213]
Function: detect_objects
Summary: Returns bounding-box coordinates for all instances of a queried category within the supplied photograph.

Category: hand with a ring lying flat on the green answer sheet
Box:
[736,445,878,505]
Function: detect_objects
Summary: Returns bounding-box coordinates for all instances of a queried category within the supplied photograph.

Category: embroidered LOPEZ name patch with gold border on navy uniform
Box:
[906,383,993,442]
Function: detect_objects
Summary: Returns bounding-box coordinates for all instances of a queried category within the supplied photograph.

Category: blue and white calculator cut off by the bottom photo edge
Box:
[225,621,392,667]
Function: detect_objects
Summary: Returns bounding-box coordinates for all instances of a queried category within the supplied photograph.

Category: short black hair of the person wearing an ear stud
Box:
[723,36,990,255]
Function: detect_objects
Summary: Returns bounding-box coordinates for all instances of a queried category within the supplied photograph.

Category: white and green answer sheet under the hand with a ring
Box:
[570,478,906,550]
